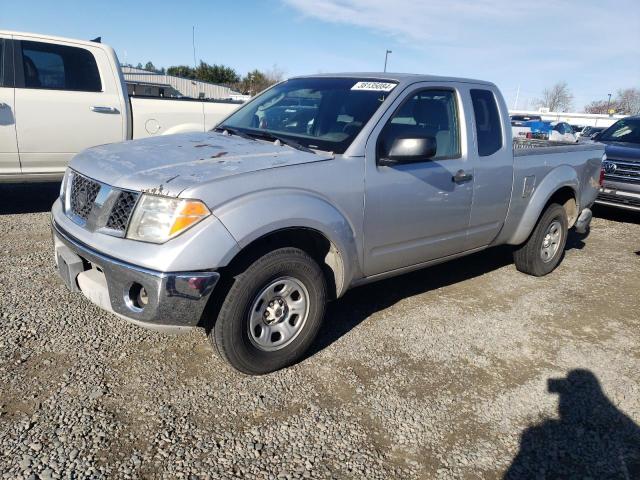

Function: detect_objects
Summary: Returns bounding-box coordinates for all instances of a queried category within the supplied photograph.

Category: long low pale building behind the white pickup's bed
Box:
[122,66,249,101]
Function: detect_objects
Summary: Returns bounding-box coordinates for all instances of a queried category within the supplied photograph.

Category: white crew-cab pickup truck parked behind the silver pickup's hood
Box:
[0,30,239,182]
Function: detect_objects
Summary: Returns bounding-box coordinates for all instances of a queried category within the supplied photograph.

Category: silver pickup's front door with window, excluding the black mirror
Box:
[364,86,473,276]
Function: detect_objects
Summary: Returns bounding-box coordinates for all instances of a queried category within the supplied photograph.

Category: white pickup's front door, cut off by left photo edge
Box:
[0,36,20,177]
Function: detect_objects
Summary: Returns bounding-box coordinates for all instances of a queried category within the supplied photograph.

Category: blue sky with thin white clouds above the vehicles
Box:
[0,0,640,110]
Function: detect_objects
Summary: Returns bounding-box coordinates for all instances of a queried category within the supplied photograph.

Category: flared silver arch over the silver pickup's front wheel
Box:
[213,189,362,296]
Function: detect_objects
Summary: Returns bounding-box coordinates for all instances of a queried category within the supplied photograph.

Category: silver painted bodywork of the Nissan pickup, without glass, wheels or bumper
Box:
[52,73,604,326]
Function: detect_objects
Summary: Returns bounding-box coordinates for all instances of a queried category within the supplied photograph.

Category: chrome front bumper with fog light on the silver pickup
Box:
[51,221,220,331]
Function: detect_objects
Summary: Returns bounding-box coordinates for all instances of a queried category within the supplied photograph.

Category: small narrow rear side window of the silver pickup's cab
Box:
[471,90,502,157]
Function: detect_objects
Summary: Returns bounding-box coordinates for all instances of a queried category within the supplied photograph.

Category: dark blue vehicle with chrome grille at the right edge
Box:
[595,116,640,211]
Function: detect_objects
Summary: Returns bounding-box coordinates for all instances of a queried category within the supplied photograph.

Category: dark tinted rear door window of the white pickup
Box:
[22,41,102,92]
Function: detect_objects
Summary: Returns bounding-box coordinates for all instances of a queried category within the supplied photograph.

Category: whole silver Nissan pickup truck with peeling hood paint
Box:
[52,73,604,374]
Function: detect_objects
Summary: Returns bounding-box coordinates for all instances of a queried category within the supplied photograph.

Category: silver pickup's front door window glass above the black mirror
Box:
[378,90,460,160]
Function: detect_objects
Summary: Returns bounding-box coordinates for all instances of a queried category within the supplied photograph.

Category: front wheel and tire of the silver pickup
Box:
[209,247,327,375]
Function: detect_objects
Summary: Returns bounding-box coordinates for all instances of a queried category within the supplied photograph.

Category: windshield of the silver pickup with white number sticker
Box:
[219,78,397,153]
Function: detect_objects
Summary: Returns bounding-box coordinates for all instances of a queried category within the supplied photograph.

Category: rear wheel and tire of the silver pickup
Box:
[513,203,569,277]
